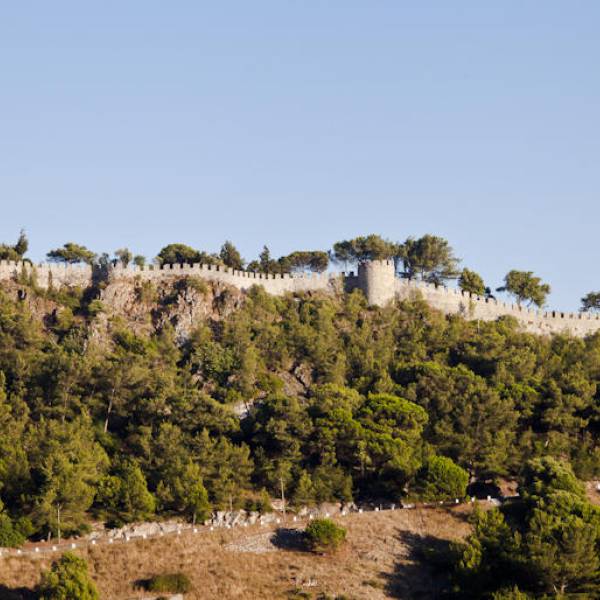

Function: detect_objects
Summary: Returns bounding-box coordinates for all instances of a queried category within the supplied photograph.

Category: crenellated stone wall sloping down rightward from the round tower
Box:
[396,279,600,336]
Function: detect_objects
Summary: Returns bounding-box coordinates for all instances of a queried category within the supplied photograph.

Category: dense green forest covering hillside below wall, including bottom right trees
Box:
[0,231,600,598]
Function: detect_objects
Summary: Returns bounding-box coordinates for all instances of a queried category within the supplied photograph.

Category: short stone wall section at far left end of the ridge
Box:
[0,260,92,289]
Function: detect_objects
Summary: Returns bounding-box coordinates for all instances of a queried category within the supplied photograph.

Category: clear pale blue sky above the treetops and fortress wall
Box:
[0,0,600,310]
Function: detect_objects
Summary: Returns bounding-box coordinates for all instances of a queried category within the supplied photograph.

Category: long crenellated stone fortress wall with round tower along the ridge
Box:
[0,260,600,337]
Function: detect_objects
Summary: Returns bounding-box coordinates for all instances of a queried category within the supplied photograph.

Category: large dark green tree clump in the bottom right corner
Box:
[455,457,600,598]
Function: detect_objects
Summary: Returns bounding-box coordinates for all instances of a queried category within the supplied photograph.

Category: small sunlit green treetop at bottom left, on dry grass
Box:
[38,552,100,600]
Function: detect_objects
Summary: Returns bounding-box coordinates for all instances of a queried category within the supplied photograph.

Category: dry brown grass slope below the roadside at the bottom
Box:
[0,507,476,600]
